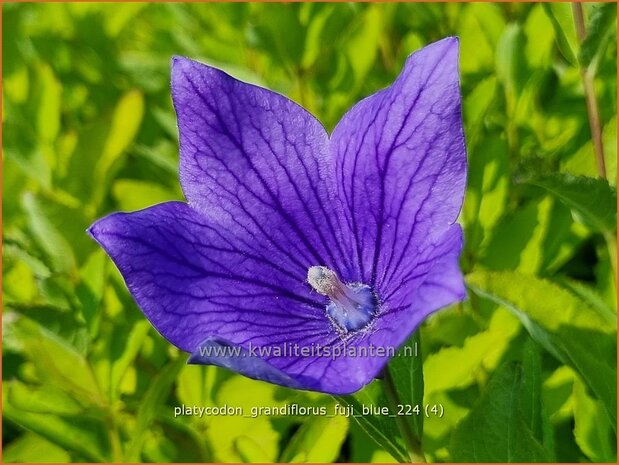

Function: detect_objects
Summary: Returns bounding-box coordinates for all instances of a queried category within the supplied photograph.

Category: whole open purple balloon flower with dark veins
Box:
[89,38,466,394]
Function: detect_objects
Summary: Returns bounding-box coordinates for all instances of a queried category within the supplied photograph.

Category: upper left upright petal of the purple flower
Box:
[172,58,351,276]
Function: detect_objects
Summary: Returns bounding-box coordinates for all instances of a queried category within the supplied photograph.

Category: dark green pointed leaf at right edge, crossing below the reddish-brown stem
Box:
[529,173,617,232]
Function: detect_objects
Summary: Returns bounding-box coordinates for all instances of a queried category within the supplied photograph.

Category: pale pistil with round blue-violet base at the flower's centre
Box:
[307,266,378,332]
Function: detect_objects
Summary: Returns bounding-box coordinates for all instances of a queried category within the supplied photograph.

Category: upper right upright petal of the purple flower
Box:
[331,38,466,294]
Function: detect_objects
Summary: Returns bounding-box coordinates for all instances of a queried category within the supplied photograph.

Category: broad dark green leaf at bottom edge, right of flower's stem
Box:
[449,363,547,462]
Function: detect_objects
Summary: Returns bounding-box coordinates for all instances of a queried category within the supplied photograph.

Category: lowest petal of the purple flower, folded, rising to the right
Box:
[190,225,466,395]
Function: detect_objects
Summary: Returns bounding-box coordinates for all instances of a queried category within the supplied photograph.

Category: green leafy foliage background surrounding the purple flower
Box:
[2,3,617,462]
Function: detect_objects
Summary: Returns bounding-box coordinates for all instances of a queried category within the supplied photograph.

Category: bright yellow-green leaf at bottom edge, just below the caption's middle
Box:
[279,415,348,463]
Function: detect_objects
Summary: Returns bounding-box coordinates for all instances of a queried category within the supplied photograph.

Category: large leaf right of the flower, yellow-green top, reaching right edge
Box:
[467,271,617,423]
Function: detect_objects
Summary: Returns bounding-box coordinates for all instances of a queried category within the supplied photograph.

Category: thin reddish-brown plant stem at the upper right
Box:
[572,3,606,179]
